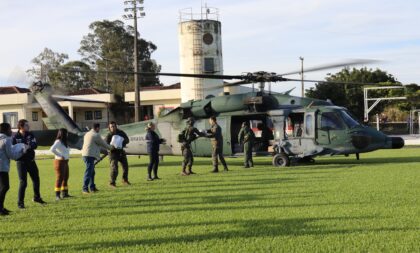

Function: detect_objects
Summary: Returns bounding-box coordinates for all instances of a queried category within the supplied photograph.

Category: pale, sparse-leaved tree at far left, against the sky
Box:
[26,48,69,81]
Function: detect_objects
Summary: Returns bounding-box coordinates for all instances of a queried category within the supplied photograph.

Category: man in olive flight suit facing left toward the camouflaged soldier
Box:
[207,116,228,173]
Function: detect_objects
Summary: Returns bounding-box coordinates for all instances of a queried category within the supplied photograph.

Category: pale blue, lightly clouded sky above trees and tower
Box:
[0,0,420,95]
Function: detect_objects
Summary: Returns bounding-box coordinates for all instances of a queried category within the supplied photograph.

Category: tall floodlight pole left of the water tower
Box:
[123,0,146,122]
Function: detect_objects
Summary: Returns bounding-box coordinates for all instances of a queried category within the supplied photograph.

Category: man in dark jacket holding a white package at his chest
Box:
[105,121,130,187]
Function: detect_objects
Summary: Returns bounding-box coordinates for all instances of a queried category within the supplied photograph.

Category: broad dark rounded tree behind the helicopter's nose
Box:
[306,68,401,120]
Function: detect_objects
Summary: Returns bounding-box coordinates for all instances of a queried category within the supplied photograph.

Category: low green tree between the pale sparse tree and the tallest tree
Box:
[49,61,95,92]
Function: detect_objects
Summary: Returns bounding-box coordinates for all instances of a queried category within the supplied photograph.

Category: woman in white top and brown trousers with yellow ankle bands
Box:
[50,128,70,200]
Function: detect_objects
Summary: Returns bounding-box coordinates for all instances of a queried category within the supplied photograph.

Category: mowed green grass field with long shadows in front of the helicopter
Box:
[0,148,420,252]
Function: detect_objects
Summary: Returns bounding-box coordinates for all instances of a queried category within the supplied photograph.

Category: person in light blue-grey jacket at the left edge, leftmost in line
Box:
[0,123,25,216]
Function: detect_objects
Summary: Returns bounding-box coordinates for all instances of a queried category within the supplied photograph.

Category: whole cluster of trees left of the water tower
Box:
[27,20,161,96]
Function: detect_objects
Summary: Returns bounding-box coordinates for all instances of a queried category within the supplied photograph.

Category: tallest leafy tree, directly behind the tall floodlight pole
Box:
[79,20,160,95]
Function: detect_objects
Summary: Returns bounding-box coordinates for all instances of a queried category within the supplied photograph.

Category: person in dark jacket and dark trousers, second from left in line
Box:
[13,119,46,209]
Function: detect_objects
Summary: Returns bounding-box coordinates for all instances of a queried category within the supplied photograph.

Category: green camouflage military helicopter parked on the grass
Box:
[31,60,404,166]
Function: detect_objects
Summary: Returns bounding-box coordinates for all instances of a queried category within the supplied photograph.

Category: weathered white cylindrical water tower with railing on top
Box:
[178,6,223,102]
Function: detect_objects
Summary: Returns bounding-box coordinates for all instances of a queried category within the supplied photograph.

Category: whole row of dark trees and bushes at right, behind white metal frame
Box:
[305,67,420,121]
